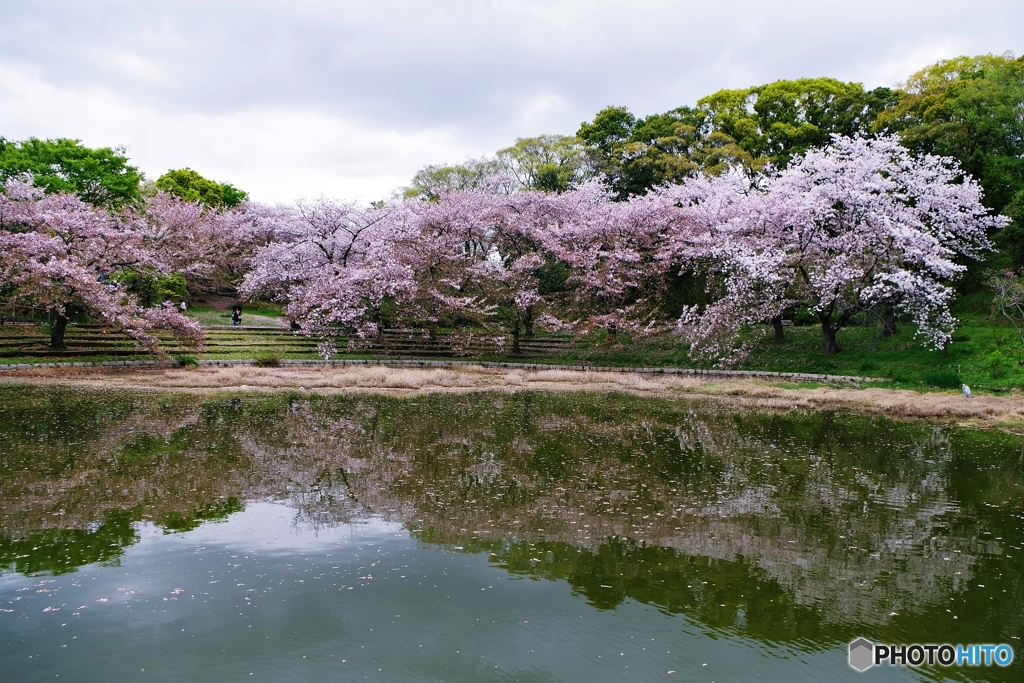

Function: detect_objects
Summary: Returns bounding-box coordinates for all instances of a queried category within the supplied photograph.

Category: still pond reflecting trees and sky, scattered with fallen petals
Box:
[0,386,1024,682]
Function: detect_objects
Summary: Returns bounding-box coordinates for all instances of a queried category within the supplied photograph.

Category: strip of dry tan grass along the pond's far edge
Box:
[8,364,1024,434]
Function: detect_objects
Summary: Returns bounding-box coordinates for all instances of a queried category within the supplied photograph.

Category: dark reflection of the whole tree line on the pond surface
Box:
[0,391,1021,651]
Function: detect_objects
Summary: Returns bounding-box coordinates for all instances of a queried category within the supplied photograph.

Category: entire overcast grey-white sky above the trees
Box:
[0,0,1024,201]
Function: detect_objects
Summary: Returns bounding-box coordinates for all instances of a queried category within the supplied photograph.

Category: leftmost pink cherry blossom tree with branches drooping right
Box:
[0,180,202,352]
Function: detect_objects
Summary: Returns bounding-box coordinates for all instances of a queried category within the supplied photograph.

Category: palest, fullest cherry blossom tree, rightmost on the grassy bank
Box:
[670,136,1005,361]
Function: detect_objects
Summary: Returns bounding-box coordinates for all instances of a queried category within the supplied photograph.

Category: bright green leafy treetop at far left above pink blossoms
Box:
[0,137,142,207]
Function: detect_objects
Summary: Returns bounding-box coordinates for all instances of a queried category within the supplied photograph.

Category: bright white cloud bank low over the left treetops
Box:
[0,63,485,202]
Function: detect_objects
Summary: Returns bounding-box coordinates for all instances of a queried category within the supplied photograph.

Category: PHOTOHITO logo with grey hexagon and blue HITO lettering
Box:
[850,638,1014,672]
